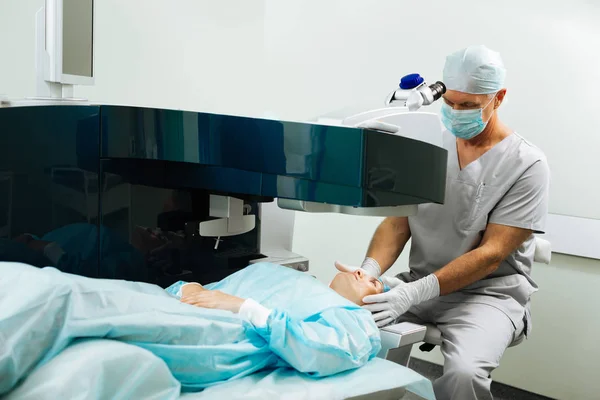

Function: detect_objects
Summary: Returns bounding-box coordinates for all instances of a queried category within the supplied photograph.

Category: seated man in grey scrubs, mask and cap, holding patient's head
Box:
[336,46,549,400]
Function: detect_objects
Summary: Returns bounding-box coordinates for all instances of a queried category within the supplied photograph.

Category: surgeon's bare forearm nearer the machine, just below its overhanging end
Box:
[367,217,410,274]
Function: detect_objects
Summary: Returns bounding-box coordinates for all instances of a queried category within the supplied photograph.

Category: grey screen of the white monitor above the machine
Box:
[62,0,94,78]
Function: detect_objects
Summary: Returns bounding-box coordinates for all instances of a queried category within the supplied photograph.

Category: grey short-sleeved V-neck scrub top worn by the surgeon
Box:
[402,132,550,333]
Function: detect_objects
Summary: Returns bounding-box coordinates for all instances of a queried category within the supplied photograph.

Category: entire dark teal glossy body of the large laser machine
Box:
[0,106,446,286]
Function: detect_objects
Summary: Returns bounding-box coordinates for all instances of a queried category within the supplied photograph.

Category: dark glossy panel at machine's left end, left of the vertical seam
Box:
[0,106,101,276]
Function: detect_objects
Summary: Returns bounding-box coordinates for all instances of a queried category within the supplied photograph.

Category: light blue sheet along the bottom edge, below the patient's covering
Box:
[3,339,435,400]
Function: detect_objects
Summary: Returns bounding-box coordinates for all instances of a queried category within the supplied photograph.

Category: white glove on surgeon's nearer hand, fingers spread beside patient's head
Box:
[363,274,440,328]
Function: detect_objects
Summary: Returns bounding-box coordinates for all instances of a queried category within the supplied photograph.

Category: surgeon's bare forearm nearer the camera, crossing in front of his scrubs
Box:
[434,247,502,296]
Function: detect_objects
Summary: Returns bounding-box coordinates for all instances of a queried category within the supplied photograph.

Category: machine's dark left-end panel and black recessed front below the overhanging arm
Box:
[0,106,262,286]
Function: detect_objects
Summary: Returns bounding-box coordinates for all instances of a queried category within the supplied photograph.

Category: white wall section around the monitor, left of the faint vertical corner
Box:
[0,0,265,115]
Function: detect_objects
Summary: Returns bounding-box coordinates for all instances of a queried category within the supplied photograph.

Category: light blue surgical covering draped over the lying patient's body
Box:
[0,263,380,395]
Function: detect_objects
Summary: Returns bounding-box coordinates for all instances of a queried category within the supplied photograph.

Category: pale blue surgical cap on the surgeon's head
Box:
[443,45,506,94]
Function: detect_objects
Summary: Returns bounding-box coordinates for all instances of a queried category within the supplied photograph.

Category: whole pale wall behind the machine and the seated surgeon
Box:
[0,0,600,399]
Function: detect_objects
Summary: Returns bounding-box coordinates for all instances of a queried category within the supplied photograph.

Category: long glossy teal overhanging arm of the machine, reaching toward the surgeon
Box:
[102,106,446,207]
